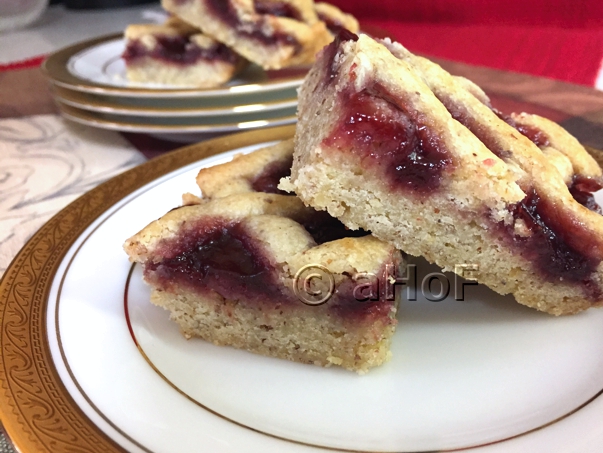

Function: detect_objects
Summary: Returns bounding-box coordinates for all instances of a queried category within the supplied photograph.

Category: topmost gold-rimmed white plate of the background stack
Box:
[43,35,309,99]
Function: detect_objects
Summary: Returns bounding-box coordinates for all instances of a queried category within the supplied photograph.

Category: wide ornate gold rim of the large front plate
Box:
[0,125,295,453]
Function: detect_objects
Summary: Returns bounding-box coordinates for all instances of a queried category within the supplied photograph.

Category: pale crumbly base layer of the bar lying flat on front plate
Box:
[151,289,395,374]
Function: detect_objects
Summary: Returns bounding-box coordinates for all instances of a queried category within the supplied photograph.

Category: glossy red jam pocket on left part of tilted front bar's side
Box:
[323,86,453,194]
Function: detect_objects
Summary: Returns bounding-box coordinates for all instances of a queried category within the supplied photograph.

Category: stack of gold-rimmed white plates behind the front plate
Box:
[43,35,308,139]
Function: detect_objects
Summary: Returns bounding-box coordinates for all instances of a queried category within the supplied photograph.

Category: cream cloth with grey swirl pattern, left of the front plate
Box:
[0,115,146,453]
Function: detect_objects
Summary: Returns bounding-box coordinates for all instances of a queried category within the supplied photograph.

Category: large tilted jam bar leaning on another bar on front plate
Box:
[280,32,603,315]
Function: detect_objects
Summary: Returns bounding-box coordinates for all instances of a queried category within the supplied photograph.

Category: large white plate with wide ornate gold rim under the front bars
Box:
[0,127,603,453]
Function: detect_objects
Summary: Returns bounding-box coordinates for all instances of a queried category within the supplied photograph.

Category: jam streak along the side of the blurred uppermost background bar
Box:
[206,0,301,52]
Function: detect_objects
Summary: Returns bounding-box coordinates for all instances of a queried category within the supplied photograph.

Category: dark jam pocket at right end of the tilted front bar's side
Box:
[505,190,603,299]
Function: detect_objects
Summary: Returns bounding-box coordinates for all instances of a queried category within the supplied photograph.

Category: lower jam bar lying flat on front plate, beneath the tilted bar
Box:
[124,141,402,373]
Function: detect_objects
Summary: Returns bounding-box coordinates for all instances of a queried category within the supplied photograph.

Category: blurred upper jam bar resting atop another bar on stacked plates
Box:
[162,0,332,69]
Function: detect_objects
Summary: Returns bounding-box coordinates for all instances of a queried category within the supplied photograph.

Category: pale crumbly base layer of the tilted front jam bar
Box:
[295,145,602,315]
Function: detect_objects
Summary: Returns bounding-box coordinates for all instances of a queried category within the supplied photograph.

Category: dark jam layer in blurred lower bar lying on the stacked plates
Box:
[122,36,237,65]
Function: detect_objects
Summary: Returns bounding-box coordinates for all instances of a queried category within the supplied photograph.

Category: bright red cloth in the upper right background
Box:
[330,0,603,86]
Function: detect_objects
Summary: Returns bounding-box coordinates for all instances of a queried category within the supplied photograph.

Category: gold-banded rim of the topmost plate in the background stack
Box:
[42,32,303,98]
